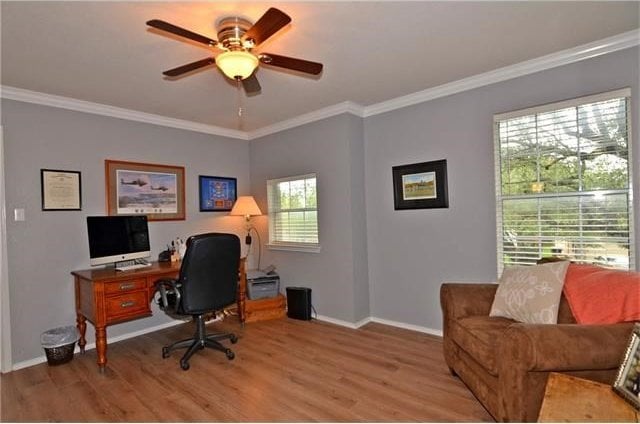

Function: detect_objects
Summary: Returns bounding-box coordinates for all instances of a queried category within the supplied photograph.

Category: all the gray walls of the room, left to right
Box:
[2,48,640,363]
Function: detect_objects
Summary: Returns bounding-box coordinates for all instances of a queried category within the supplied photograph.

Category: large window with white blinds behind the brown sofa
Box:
[494,89,635,273]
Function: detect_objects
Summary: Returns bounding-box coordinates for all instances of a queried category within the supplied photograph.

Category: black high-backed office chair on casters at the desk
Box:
[154,233,240,371]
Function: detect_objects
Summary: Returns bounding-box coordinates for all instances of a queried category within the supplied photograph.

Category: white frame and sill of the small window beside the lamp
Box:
[266,172,321,253]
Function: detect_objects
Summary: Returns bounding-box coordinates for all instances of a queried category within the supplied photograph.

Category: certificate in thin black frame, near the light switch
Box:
[40,169,82,211]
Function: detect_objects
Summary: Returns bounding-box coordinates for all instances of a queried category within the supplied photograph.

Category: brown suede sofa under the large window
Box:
[440,283,633,422]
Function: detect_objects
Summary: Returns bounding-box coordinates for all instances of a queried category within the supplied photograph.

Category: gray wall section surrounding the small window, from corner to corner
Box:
[251,114,369,322]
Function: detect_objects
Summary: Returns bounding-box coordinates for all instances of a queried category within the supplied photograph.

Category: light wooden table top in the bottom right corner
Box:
[538,373,640,423]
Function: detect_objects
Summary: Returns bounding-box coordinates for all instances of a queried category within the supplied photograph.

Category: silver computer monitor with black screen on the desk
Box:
[87,215,151,266]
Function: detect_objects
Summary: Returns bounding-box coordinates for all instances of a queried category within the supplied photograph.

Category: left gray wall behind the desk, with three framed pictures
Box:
[2,100,249,363]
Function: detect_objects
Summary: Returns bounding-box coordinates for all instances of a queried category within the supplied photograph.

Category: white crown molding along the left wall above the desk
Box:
[0,85,247,140]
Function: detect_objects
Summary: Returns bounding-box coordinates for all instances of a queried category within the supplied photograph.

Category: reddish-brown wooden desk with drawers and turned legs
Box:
[71,258,246,371]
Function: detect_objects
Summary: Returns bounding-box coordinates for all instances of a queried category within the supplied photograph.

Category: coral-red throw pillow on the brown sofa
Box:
[563,264,640,324]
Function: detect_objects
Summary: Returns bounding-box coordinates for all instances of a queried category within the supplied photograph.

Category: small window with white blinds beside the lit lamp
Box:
[267,174,320,252]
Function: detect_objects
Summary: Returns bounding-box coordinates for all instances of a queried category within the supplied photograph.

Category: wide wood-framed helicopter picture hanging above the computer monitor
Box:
[104,159,185,221]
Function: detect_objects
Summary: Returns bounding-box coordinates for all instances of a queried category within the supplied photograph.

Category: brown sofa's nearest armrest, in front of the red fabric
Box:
[496,323,633,422]
